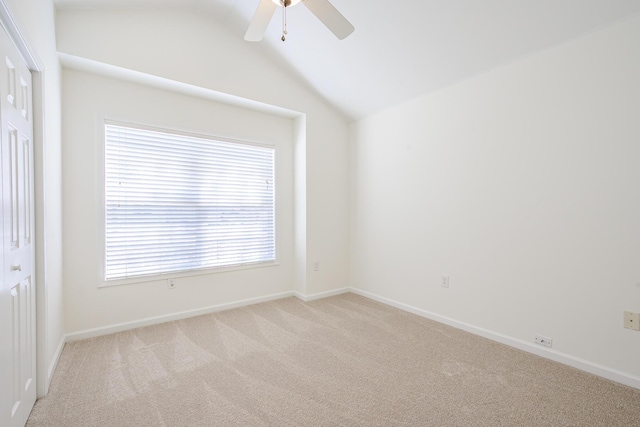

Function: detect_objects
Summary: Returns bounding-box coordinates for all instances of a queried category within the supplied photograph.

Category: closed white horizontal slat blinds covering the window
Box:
[105,124,276,280]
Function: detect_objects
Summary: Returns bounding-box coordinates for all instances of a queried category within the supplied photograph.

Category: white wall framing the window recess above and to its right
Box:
[56,5,349,304]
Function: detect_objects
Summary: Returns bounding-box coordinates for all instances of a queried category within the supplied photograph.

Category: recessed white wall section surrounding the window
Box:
[62,69,294,333]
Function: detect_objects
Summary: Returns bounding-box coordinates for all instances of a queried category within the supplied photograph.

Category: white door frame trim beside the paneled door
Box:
[0,0,49,398]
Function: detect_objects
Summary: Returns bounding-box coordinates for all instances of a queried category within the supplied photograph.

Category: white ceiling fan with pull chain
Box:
[244,0,354,42]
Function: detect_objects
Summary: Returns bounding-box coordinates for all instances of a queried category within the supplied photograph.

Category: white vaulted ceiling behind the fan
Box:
[55,0,640,119]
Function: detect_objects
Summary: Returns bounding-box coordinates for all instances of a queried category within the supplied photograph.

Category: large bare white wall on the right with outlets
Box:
[350,14,640,384]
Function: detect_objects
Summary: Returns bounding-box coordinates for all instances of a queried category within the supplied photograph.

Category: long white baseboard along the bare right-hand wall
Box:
[350,288,640,389]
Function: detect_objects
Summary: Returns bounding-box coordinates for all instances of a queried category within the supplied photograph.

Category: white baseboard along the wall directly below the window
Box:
[65,292,294,342]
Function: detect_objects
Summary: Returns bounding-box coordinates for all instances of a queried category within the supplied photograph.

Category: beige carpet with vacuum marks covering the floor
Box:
[27,294,640,427]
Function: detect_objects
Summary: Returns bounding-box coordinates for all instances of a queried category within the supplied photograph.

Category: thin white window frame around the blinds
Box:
[96,117,281,288]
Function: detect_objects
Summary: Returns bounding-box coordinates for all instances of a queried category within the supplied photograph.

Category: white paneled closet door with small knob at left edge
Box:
[0,21,36,427]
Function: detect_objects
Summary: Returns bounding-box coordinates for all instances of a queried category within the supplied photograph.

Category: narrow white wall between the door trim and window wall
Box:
[4,0,64,394]
